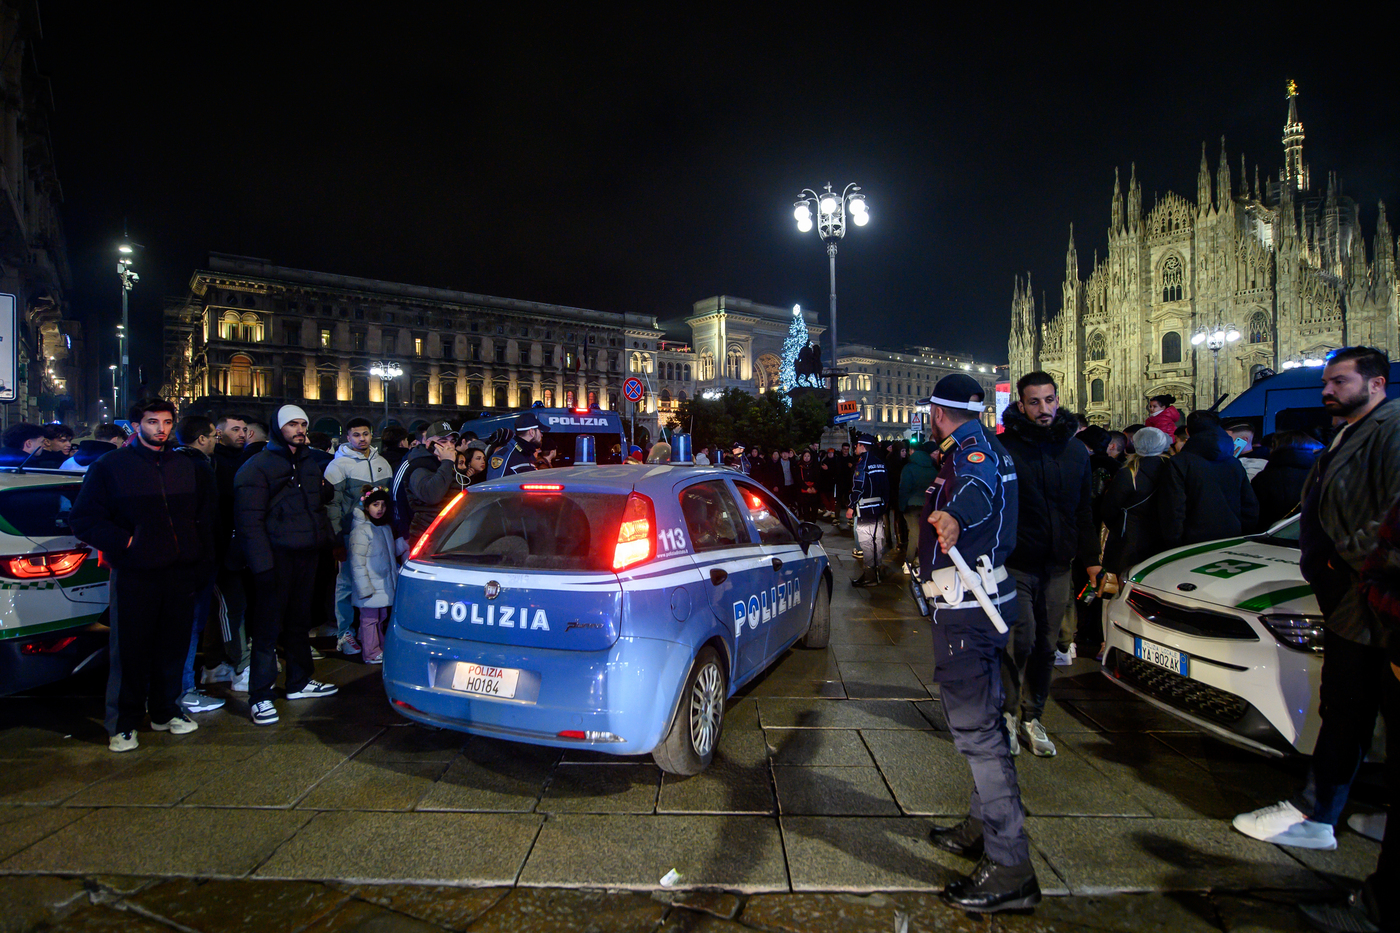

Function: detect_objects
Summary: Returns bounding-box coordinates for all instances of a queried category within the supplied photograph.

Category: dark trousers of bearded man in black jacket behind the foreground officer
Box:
[1001,570,1071,721]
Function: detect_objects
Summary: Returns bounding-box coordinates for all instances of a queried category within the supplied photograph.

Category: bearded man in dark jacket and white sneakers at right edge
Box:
[1237,346,1400,930]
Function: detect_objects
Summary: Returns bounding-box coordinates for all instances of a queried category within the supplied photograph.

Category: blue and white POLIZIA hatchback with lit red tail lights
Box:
[384,451,832,775]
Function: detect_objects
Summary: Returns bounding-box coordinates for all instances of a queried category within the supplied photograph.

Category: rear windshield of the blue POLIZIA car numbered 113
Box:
[419,489,627,572]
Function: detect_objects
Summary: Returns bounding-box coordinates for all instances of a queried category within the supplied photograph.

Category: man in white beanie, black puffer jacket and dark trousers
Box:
[234,405,337,726]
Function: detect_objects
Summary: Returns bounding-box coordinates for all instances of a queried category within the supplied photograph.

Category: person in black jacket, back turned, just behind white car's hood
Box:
[1158,410,1259,548]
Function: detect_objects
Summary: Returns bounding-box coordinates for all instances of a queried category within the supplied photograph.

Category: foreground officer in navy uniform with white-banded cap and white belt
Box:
[918,373,1040,912]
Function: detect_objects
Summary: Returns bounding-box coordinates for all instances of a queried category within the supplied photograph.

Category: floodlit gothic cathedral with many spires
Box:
[1008,83,1400,427]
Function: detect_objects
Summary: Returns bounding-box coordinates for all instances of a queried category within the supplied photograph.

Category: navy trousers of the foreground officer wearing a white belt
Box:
[938,653,1030,866]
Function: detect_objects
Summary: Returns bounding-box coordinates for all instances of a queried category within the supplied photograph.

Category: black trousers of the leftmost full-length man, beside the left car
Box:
[105,566,200,735]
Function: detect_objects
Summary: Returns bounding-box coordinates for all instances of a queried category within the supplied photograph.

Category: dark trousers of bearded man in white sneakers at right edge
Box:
[1294,632,1400,835]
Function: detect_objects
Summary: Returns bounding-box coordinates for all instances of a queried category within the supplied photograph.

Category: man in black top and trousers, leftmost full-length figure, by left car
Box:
[69,399,216,752]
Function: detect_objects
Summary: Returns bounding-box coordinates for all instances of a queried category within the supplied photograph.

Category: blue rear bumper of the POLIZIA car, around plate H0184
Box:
[384,623,693,755]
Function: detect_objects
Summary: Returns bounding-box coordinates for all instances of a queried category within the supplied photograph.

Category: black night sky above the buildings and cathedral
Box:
[36,3,1400,378]
